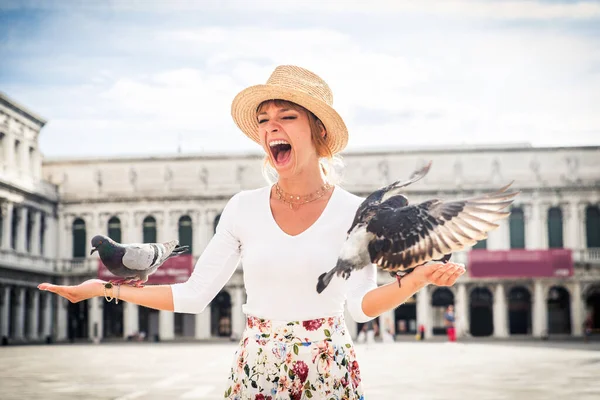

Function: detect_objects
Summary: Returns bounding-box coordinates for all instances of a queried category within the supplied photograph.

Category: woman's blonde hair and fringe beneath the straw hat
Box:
[256,99,344,185]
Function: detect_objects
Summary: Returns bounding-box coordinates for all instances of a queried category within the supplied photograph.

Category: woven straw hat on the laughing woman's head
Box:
[231,65,348,154]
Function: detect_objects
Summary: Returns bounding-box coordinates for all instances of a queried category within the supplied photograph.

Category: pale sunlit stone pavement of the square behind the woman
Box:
[0,342,600,400]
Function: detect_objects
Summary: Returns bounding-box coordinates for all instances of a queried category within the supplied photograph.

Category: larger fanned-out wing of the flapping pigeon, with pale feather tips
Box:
[367,185,519,271]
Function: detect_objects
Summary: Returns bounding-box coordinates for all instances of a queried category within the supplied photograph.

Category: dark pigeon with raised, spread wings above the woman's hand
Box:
[317,162,519,293]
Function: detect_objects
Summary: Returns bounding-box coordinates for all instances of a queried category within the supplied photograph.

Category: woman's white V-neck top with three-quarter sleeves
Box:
[171,186,377,322]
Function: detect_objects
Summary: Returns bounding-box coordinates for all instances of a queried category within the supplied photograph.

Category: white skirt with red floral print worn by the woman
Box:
[225,316,364,400]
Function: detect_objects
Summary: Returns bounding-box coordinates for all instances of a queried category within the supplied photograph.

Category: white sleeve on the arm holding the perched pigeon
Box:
[171,193,241,314]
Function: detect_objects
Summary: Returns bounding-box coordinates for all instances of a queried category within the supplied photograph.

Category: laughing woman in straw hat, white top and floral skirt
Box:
[39,66,465,399]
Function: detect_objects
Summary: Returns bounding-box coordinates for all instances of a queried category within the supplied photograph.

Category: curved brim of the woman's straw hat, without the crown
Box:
[231,85,348,154]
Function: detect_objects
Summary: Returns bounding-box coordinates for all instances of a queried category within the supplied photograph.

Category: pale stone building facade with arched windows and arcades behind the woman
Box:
[0,91,600,341]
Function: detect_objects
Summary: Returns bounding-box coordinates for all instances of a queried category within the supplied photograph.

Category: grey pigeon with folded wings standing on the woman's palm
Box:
[90,235,189,287]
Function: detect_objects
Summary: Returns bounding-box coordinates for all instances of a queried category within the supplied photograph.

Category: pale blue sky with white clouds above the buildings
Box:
[0,0,600,158]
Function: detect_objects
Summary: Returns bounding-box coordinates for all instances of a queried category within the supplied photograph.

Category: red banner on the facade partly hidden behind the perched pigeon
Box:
[98,254,194,285]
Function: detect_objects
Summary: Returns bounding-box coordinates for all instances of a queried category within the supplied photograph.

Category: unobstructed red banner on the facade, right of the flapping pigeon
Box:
[467,249,573,278]
